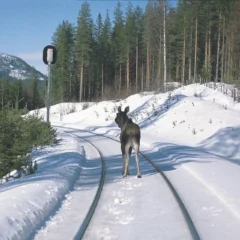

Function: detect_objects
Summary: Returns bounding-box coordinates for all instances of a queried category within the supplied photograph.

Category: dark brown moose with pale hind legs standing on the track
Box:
[115,106,141,178]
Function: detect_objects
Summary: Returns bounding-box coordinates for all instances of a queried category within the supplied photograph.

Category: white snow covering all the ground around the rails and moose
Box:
[0,84,240,240]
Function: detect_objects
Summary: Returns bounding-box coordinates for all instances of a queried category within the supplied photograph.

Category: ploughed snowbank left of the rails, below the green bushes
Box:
[0,133,84,239]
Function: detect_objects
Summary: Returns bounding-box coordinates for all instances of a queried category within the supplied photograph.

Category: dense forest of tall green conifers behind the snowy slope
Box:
[0,0,240,109]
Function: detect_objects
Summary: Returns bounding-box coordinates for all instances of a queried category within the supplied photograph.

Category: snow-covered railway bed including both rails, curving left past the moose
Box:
[62,130,200,240]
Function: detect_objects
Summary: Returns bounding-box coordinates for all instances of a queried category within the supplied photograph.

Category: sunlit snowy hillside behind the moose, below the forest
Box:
[32,84,240,157]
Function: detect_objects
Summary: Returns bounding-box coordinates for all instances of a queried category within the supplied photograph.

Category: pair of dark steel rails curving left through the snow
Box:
[59,127,200,240]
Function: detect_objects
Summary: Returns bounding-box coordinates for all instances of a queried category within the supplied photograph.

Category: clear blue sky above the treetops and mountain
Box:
[0,0,150,74]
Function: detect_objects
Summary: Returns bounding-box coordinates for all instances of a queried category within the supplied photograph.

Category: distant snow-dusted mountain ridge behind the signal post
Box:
[0,53,47,80]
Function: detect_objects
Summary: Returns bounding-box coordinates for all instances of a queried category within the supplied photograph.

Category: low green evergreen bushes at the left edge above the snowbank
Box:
[0,107,56,177]
